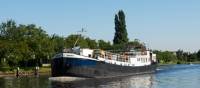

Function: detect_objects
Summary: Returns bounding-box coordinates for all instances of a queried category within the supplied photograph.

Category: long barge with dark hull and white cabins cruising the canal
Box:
[51,47,156,78]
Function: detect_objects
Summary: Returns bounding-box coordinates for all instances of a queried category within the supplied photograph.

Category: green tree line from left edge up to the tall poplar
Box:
[0,20,111,67]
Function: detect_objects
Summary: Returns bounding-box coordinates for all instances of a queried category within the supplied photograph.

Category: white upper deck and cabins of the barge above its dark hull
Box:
[55,48,156,66]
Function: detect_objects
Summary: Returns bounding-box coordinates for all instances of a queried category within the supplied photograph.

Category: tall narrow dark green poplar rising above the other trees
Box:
[113,10,129,45]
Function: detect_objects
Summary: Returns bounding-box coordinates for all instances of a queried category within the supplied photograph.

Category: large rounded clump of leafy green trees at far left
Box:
[0,20,55,67]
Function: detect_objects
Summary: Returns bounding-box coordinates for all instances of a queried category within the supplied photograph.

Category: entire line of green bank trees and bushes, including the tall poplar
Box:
[0,10,200,76]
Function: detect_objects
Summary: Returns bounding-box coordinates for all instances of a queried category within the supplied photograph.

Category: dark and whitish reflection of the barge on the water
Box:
[51,74,154,88]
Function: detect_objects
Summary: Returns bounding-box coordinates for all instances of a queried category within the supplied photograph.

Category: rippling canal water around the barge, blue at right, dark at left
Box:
[0,64,200,88]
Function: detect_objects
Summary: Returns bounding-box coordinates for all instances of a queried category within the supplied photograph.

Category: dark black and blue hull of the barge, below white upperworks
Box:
[52,58,156,78]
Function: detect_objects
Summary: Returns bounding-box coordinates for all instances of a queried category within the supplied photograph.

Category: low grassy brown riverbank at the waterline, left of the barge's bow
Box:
[0,67,51,77]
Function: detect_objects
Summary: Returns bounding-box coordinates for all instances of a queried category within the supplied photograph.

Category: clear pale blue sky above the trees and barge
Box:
[0,0,200,52]
